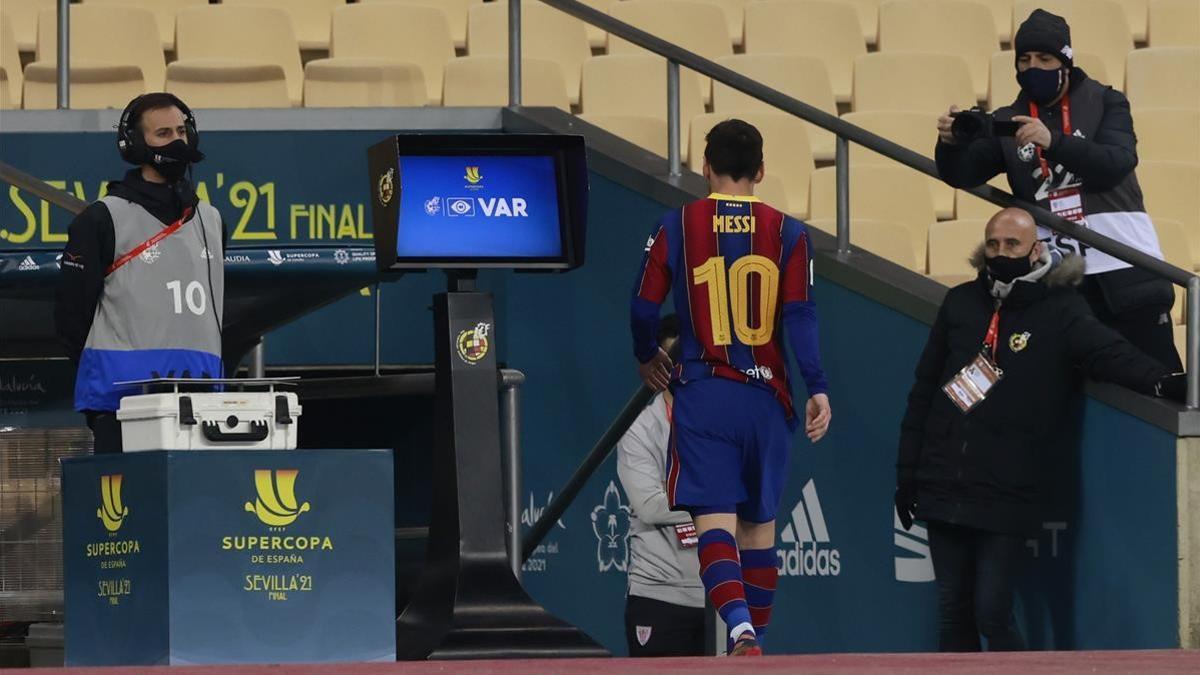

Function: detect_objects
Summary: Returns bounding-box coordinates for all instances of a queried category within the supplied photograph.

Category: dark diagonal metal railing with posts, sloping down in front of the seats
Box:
[509,0,1200,410]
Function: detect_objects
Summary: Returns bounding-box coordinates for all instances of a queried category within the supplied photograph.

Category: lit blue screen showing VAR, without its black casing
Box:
[396,155,564,259]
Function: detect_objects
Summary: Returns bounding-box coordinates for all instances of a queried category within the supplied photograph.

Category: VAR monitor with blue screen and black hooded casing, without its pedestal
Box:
[367,133,588,270]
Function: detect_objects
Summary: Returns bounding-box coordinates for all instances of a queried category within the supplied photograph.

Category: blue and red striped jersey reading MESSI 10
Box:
[631,193,828,418]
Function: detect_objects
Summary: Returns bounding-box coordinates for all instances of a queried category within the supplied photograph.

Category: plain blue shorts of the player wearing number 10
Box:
[666,377,792,522]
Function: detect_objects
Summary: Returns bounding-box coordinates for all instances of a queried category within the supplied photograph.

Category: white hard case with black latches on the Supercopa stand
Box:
[116,392,301,453]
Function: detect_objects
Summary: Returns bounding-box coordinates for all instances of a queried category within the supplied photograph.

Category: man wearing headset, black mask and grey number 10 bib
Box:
[55,92,224,454]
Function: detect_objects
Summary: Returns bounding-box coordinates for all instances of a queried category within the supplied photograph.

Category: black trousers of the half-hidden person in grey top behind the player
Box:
[625,596,704,656]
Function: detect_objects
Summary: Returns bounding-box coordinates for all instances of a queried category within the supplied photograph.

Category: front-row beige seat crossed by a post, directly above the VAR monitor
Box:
[442,56,571,113]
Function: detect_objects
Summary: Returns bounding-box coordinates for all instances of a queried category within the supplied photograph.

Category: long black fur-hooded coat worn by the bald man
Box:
[896,252,1166,534]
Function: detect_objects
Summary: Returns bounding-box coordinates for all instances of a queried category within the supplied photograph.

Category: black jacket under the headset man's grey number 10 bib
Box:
[54,168,206,364]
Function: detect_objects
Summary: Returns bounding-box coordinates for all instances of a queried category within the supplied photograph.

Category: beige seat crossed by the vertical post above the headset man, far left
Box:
[25,5,167,90]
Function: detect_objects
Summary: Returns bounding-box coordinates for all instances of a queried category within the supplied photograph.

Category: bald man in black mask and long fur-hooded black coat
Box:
[895,209,1184,651]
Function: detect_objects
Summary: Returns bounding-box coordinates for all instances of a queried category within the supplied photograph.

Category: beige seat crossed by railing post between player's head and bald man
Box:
[809,165,937,273]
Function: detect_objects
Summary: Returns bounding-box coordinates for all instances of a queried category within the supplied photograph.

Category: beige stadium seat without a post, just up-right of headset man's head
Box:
[174,5,304,107]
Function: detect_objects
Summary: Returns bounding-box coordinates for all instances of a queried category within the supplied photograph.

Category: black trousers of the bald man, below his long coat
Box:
[929,522,1026,651]
